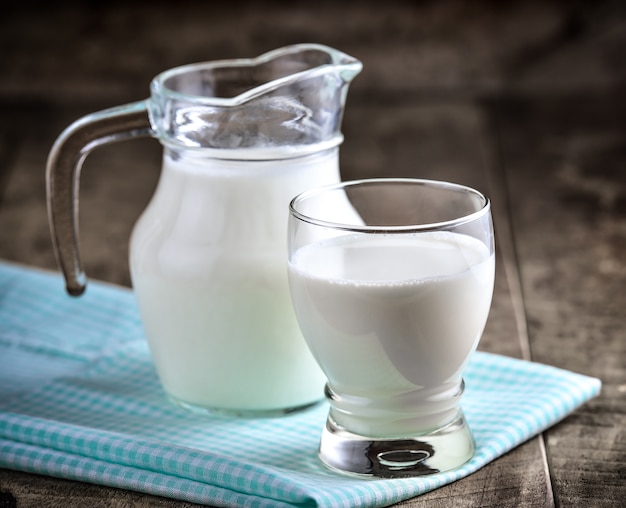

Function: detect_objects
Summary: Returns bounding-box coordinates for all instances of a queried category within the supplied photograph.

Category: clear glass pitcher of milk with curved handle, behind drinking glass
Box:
[46,44,362,416]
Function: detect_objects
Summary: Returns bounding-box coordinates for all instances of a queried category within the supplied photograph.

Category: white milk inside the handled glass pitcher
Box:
[130,149,339,411]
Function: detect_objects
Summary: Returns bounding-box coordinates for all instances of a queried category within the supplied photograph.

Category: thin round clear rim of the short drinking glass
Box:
[289,177,491,234]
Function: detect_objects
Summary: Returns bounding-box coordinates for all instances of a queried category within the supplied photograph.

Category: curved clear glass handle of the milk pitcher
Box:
[46,100,154,296]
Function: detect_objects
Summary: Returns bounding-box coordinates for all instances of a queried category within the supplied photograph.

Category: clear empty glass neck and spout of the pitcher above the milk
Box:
[150,44,362,159]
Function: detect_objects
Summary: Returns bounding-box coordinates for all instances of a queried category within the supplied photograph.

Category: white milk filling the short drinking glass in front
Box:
[289,232,494,436]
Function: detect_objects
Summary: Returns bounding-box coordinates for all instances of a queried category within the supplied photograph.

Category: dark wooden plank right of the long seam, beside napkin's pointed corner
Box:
[497,90,626,506]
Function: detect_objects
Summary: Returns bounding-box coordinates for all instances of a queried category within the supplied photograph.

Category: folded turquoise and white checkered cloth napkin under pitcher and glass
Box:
[0,263,600,508]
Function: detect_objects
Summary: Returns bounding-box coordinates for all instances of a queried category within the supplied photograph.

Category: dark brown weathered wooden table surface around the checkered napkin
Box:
[0,1,626,507]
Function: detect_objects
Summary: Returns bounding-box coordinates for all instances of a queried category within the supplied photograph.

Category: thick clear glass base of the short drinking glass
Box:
[319,411,474,478]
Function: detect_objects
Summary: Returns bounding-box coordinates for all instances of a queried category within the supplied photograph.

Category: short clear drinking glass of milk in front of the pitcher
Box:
[288,179,495,477]
